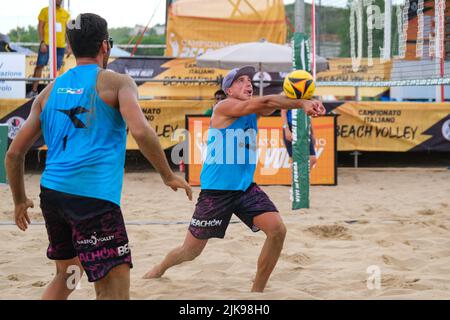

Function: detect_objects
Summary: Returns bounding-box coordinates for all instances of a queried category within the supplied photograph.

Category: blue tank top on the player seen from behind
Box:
[40,64,126,205]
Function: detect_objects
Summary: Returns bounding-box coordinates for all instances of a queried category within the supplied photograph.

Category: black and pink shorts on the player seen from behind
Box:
[40,186,133,282]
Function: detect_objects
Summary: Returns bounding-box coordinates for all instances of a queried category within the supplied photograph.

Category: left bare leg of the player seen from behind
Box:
[42,257,83,300]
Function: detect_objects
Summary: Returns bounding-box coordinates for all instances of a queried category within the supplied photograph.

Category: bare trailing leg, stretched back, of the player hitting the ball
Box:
[144,231,208,279]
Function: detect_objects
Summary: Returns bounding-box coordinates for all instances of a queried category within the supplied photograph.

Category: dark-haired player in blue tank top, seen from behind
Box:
[5,13,192,299]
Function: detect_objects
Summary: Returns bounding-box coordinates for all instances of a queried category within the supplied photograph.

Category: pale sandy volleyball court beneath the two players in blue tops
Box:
[0,168,450,300]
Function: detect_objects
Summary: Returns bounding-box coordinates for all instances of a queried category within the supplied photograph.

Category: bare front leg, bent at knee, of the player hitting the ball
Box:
[252,212,286,292]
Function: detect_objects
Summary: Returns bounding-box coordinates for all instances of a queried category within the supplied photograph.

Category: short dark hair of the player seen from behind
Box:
[67,13,109,58]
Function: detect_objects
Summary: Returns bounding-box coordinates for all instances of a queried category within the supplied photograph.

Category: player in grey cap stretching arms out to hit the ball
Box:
[144,67,325,292]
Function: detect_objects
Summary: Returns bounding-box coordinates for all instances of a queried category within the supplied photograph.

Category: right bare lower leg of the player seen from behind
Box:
[95,263,130,300]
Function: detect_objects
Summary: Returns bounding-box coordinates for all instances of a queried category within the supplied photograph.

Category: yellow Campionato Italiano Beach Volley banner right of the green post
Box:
[326,102,450,152]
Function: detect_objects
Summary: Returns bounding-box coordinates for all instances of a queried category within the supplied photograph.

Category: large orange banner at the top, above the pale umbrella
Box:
[166,0,286,58]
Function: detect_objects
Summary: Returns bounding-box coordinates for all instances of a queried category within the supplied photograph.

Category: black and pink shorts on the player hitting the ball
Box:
[189,183,278,239]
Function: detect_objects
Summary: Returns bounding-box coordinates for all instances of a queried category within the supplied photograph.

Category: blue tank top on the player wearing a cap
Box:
[200,114,258,191]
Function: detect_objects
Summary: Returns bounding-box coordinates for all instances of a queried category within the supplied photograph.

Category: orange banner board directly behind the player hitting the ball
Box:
[186,116,337,186]
